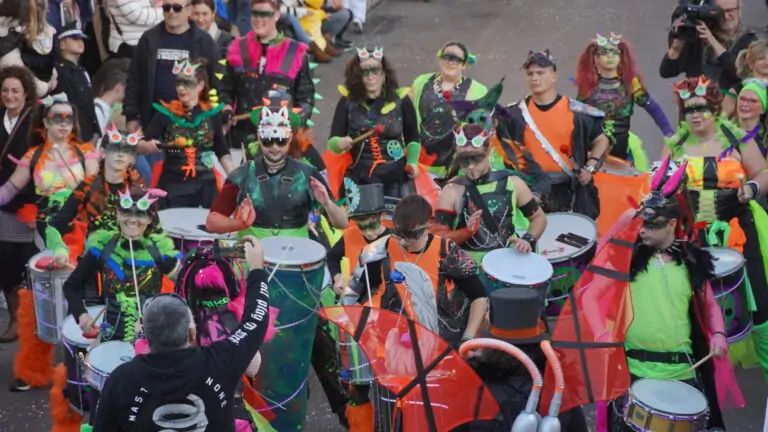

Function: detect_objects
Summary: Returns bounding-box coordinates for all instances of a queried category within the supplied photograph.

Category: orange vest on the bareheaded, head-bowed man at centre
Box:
[379,236,455,321]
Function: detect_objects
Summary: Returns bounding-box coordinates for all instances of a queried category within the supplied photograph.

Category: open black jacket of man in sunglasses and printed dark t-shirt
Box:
[123,22,222,128]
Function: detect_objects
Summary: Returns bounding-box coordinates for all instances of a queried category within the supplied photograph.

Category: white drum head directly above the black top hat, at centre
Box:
[483,249,552,287]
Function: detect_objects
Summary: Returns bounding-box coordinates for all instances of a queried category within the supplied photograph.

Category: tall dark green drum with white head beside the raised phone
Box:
[254,237,326,431]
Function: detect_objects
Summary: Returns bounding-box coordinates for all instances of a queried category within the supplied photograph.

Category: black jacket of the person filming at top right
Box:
[659,30,757,90]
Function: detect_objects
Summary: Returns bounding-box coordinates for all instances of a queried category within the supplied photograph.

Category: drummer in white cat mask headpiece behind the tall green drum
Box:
[206,101,348,239]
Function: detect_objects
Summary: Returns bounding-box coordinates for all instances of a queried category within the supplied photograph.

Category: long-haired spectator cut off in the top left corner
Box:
[0,0,57,97]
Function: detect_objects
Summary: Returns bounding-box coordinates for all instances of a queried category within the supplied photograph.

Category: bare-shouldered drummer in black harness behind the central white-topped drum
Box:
[433,124,547,262]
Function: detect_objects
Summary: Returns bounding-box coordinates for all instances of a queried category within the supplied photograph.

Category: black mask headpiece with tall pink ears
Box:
[637,156,688,221]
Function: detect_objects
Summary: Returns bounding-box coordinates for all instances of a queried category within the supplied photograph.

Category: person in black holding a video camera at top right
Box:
[659,0,757,89]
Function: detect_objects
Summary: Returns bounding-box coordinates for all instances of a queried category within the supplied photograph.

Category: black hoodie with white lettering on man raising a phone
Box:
[93,270,269,432]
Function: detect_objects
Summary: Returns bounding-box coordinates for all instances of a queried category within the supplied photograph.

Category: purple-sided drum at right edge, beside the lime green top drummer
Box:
[706,247,752,343]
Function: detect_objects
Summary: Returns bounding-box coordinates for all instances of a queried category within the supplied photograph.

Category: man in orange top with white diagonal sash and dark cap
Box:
[498,49,610,219]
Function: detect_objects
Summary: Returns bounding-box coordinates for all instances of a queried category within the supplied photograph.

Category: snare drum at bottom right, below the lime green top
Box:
[624,379,709,432]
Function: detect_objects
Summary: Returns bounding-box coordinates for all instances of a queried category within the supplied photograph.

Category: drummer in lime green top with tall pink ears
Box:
[580,161,730,431]
